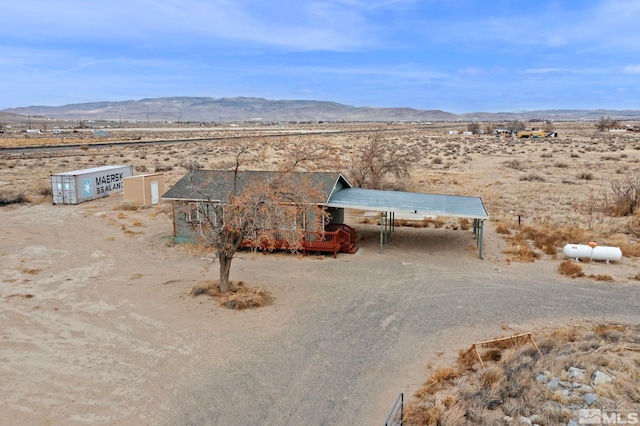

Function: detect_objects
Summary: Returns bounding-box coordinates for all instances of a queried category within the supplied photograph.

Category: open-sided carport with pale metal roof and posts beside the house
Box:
[326,188,489,259]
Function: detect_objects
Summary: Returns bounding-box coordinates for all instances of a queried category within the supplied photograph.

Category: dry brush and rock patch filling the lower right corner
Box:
[403,323,640,426]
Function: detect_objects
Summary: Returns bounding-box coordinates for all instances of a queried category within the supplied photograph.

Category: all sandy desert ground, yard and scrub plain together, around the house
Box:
[0,123,640,425]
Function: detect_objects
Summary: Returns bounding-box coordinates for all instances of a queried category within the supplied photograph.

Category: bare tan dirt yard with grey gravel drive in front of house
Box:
[0,197,640,425]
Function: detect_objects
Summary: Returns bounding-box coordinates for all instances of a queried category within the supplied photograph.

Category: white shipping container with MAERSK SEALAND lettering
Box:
[51,166,133,204]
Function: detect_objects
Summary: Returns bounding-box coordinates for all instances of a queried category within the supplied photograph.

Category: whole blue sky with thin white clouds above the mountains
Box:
[0,0,640,113]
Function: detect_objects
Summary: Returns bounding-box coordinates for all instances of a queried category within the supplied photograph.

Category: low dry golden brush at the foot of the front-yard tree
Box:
[191,281,273,310]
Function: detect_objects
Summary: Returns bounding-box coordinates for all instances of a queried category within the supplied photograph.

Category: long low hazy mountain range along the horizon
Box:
[0,96,640,122]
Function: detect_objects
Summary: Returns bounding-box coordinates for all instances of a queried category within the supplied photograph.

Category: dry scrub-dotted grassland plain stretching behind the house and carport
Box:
[0,123,640,278]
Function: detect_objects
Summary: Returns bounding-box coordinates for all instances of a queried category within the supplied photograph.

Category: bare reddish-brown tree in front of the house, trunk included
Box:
[185,149,326,294]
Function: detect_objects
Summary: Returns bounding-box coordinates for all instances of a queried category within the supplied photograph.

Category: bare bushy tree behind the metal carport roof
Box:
[348,130,418,189]
